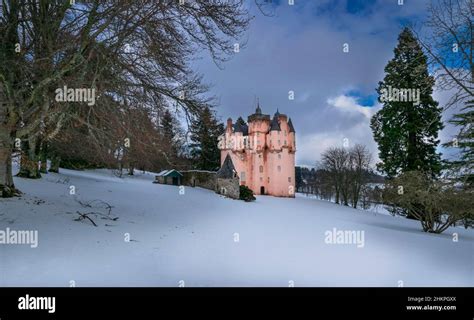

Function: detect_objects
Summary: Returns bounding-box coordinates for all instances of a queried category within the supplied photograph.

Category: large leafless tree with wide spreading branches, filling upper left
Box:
[0,0,250,196]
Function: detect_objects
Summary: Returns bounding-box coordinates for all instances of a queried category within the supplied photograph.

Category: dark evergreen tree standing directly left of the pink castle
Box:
[190,107,224,170]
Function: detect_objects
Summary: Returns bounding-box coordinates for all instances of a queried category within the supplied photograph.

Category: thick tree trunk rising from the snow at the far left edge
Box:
[0,124,19,198]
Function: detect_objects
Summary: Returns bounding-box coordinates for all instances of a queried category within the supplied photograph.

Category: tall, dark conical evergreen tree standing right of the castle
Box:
[371,28,443,177]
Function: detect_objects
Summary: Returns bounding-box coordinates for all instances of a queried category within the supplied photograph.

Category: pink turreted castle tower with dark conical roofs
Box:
[219,105,296,198]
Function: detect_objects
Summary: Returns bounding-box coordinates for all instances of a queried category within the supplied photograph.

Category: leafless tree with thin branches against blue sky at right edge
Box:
[413,0,474,186]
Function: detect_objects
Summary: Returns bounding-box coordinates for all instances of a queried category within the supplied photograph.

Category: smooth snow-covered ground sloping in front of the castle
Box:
[0,169,474,287]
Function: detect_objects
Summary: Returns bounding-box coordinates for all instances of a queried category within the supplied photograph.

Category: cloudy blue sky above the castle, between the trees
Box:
[194,0,455,166]
